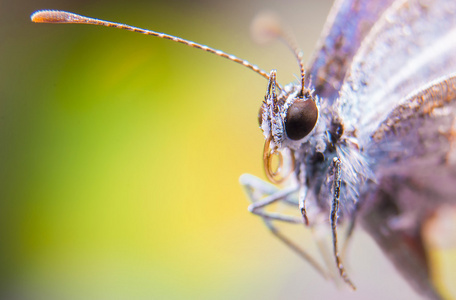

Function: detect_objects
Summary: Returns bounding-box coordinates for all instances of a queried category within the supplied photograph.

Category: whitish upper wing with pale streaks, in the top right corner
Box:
[337,0,456,145]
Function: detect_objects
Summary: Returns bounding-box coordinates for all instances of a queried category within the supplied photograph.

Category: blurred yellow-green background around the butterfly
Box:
[0,0,456,300]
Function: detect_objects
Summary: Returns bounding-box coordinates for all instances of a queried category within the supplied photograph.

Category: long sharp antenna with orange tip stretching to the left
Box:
[30,10,269,80]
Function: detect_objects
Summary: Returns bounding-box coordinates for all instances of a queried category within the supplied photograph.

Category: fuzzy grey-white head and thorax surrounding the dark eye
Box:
[261,79,366,220]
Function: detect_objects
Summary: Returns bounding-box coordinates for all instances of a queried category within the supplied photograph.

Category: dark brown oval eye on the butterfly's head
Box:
[285,98,318,141]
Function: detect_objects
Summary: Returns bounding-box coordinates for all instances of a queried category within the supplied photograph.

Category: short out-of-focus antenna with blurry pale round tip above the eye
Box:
[251,12,307,96]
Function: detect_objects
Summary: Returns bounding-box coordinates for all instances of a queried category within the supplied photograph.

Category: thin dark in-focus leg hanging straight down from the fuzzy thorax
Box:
[331,157,356,290]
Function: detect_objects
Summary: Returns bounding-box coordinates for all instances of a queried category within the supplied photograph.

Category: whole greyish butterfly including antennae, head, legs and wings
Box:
[31,0,456,299]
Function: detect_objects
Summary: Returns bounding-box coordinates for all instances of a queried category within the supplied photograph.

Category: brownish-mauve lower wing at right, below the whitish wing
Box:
[360,73,456,299]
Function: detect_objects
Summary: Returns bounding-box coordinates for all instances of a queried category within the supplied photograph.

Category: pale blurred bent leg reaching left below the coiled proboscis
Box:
[239,174,330,278]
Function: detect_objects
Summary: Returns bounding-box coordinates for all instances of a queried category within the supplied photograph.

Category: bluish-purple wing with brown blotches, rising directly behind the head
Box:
[307,0,393,101]
